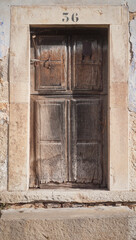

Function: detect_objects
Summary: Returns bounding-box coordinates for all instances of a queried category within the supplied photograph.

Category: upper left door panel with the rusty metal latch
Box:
[36,35,67,91]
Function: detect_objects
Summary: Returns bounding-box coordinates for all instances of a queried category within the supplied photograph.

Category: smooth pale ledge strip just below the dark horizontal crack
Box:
[1,206,136,220]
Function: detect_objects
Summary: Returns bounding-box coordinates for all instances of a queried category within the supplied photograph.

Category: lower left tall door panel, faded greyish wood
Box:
[36,99,67,183]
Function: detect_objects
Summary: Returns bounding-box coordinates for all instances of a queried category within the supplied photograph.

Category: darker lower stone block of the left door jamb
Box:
[9,103,29,191]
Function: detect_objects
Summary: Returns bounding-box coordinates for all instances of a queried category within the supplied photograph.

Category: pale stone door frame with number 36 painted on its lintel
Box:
[8,6,129,191]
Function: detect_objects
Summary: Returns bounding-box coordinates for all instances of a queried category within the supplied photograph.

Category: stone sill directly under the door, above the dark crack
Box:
[0,189,136,205]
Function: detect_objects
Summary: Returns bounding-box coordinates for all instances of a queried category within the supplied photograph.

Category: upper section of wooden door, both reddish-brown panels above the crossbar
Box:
[31,29,107,95]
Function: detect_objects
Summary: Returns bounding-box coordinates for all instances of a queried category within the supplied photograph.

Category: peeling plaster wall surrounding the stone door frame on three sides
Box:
[0,0,136,190]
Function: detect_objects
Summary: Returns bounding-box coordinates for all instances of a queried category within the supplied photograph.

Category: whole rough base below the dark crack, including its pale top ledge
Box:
[0,207,136,240]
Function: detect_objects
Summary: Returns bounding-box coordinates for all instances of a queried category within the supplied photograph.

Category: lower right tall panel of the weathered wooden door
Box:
[71,97,103,184]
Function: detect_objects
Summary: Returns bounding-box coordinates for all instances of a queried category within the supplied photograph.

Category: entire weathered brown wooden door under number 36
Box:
[30,29,107,188]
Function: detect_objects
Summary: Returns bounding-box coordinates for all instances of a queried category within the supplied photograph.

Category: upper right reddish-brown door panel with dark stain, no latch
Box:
[72,35,103,91]
